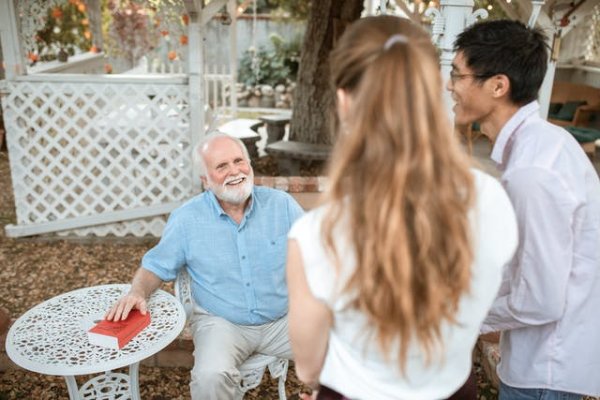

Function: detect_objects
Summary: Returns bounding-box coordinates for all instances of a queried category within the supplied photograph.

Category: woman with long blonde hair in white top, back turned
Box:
[287,16,517,400]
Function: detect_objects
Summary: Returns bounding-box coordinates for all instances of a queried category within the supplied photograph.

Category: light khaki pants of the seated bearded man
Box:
[190,305,292,400]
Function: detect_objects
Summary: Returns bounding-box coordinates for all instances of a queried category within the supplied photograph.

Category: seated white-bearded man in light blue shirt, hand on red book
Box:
[107,134,302,400]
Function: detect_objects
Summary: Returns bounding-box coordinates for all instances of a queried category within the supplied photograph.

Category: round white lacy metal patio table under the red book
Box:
[6,284,185,400]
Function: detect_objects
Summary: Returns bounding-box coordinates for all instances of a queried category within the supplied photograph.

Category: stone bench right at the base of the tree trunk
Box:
[265,140,332,176]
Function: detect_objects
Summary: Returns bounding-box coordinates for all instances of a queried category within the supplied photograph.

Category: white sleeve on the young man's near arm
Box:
[481,168,577,333]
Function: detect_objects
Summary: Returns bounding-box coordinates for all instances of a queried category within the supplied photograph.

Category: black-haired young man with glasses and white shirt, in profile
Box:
[448,20,600,400]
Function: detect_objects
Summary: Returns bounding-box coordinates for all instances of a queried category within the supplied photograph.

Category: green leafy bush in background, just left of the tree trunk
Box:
[238,34,301,86]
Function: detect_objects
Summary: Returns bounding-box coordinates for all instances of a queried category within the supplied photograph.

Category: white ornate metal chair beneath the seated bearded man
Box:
[175,267,289,400]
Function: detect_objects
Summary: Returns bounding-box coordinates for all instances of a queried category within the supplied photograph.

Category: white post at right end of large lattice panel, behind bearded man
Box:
[188,13,206,192]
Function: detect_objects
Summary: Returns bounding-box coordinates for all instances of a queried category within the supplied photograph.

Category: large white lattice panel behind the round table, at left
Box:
[3,78,192,236]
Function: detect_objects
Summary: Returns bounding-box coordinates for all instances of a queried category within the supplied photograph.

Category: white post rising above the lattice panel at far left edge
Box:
[0,0,27,80]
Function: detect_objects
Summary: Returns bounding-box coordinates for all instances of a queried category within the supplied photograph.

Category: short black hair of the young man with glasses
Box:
[454,19,548,105]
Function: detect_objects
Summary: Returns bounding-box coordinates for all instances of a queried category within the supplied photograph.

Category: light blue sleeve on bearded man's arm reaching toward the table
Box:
[142,212,187,281]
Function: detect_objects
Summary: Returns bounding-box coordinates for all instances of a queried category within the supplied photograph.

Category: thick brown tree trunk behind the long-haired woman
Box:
[290,0,363,143]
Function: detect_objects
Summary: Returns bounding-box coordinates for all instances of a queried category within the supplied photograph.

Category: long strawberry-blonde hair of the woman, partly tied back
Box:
[322,16,474,370]
